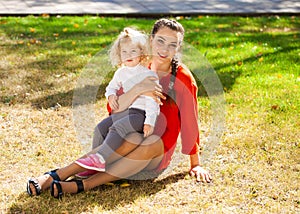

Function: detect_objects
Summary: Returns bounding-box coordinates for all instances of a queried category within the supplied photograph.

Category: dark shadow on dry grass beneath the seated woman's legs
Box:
[7,172,186,213]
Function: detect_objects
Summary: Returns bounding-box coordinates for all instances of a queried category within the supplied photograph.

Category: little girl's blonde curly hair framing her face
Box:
[109,27,149,66]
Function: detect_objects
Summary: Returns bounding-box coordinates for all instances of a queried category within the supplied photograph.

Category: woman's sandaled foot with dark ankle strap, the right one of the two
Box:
[50,180,84,199]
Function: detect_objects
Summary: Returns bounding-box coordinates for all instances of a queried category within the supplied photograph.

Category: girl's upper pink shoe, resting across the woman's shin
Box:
[75,154,105,172]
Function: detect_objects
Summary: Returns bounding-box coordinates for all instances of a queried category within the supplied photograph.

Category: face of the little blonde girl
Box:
[120,41,142,67]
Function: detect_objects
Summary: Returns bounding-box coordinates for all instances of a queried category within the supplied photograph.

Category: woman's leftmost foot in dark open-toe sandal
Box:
[27,169,60,196]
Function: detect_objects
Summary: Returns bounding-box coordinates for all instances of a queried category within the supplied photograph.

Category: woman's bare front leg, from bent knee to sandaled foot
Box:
[54,135,164,195]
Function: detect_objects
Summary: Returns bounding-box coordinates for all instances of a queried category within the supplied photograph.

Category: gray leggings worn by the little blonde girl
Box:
[93,108,145,160]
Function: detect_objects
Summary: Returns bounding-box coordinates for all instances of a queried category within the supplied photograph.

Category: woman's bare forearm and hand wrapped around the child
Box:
[113,77,165,113]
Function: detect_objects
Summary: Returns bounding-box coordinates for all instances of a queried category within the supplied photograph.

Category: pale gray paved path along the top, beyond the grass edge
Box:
[0,0,300,16]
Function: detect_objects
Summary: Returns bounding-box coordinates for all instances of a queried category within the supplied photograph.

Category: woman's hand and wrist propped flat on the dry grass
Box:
[190,153,212,183]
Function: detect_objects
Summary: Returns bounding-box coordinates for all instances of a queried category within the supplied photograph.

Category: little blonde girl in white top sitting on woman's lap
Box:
[75,28,160,171]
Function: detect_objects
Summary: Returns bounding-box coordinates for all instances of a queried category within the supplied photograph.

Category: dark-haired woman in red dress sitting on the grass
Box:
[27,19,212,198]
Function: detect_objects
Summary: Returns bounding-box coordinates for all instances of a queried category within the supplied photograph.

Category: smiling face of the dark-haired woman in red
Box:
[151,27,181,64]
